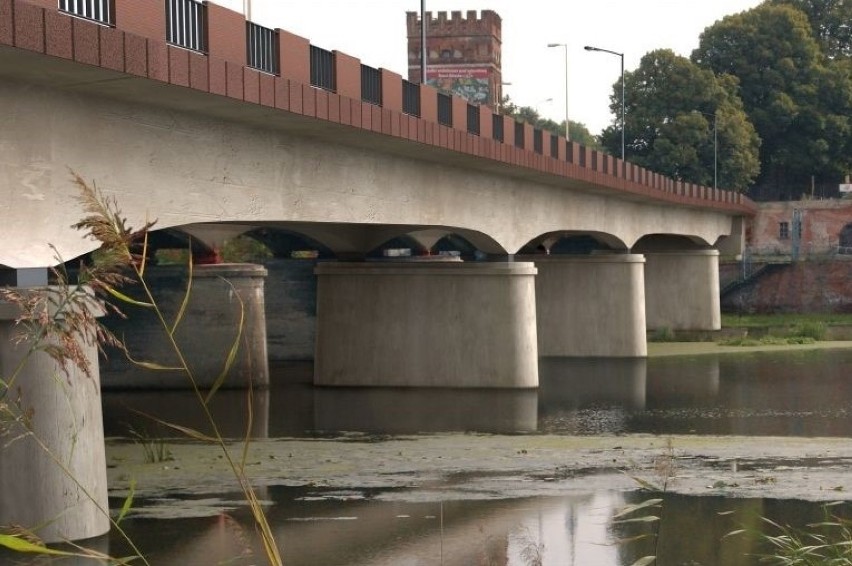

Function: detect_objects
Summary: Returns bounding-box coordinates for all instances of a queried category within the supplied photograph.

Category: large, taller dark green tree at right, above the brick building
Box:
[692,3,852,197]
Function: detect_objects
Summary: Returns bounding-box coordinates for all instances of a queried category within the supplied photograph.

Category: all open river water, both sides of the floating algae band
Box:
[5,349,852,566]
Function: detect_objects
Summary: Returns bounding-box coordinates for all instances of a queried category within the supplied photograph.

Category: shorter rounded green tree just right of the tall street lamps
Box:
[601,49,760,191]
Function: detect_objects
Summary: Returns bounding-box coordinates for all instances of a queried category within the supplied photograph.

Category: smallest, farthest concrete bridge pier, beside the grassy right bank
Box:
[645,250,722,330]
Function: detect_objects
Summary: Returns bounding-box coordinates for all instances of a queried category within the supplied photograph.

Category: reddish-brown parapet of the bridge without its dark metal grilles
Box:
[0,0,755,215]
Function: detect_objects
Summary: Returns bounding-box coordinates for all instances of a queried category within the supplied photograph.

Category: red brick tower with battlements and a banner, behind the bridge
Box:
[406,10,503,107]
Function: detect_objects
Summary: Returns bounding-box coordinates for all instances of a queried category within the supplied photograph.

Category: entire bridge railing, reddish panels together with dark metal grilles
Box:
[5,0,753,212]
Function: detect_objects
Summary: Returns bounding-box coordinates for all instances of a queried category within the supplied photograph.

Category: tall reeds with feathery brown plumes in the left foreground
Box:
[0,173,283,566]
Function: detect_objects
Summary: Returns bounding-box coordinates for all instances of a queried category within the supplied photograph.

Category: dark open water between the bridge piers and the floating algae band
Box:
[104,350,852,438]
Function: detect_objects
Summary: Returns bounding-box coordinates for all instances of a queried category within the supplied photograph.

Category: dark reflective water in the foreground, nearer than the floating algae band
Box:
[5,487,840,566]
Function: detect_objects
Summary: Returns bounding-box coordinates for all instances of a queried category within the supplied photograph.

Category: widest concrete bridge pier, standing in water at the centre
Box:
[314,261,538,388]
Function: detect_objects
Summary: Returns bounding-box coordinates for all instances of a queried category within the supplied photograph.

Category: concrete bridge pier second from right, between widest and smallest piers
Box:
[536,254,648,358]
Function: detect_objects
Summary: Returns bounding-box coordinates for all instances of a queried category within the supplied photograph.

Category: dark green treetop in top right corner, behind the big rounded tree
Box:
[767,0,852,59]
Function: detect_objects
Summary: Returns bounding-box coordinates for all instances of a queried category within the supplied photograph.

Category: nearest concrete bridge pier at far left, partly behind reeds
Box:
[0,288,110,543]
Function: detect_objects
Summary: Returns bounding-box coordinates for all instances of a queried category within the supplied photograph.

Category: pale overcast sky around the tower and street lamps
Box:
[216,0,761,134]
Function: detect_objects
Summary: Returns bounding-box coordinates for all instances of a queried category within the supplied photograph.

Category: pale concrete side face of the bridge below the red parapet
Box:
[0,80,733,267]
